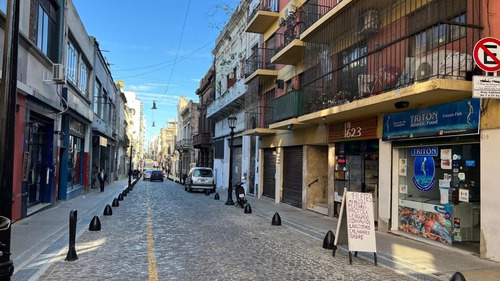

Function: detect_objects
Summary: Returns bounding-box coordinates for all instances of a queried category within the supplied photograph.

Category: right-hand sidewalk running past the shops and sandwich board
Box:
[243,194,500,281]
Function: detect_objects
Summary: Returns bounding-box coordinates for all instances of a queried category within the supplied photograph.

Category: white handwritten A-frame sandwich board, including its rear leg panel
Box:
[334,192,377,253]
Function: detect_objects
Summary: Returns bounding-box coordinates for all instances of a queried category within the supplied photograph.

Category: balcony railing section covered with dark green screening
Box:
[273,90,304,122]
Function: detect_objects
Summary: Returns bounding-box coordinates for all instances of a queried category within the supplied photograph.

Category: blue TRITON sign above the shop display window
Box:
[382,98,480,141]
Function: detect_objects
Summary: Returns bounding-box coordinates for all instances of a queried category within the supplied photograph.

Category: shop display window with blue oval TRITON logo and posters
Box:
[394,144,480,245]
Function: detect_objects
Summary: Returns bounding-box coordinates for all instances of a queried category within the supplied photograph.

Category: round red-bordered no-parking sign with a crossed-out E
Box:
[474,37,500,72]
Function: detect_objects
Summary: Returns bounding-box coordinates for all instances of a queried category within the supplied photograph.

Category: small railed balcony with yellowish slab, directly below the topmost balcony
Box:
[245,48,278,84]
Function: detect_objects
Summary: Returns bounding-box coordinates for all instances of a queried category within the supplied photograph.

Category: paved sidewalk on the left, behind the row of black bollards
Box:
[10,179,133,280]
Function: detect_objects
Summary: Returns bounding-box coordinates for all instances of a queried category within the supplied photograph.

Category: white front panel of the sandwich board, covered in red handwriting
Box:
[344,192,377,252]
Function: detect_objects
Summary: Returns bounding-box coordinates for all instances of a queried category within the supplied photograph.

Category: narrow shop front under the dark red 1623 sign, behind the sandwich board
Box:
[328,117,379,218]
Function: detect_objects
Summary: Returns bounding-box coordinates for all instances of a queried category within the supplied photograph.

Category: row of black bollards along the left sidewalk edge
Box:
[65,178,137,261]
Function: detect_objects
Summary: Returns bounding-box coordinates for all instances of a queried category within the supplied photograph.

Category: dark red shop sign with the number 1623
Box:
[328,117,377,142]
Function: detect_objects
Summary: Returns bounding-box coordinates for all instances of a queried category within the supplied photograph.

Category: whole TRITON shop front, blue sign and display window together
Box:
[382,99,481,253]
